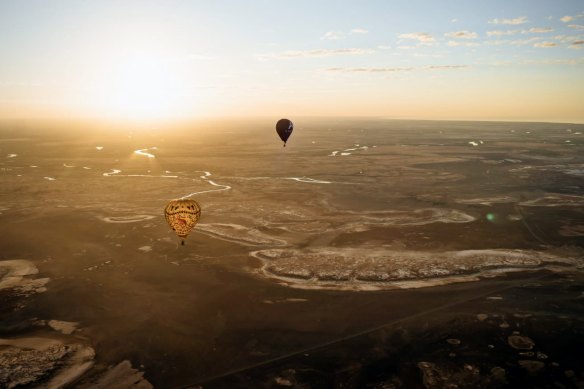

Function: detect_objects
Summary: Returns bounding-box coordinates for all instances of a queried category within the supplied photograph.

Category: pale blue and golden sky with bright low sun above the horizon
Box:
[0,0,584,123]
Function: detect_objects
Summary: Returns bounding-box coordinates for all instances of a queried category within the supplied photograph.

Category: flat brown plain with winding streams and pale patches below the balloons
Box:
[0,118,584,389]
